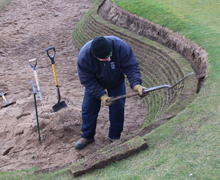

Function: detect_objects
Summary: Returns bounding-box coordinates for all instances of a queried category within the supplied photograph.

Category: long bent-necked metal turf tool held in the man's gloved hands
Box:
[108,72,194,102]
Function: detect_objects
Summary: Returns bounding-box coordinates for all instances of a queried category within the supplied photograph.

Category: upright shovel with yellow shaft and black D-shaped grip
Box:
[46,46,67,112]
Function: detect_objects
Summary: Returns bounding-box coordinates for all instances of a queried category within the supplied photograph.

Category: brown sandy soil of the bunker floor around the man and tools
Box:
[0,0,146,172]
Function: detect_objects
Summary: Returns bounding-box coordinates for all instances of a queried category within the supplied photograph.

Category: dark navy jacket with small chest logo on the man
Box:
[77,36,142,99]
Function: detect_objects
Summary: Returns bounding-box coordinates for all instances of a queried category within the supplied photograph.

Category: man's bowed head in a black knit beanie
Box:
[91,36,112,60]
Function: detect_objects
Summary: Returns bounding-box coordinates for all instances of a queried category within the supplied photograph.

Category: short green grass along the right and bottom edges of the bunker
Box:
[0,0,220,180]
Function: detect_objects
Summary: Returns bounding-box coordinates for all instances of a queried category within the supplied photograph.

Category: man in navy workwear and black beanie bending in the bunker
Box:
[75,36,145,149]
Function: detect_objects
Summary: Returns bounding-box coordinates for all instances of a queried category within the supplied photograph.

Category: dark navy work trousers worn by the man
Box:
[81,80,126,139]
